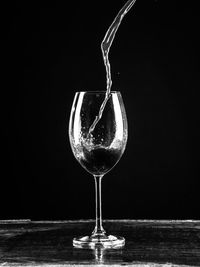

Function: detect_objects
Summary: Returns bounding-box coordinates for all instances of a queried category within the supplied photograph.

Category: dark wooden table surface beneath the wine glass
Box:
[0,220,200,267]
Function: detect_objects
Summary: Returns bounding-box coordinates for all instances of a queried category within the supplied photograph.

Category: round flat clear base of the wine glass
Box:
[73,234,125,248]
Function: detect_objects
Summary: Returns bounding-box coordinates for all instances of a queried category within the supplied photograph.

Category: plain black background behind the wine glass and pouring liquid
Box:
[0,0,200,219]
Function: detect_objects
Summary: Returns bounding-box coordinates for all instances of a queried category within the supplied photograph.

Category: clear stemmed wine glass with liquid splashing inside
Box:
[69,91,128,248]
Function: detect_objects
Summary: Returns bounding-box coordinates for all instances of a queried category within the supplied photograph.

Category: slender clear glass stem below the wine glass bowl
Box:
[92,175,105,235]
